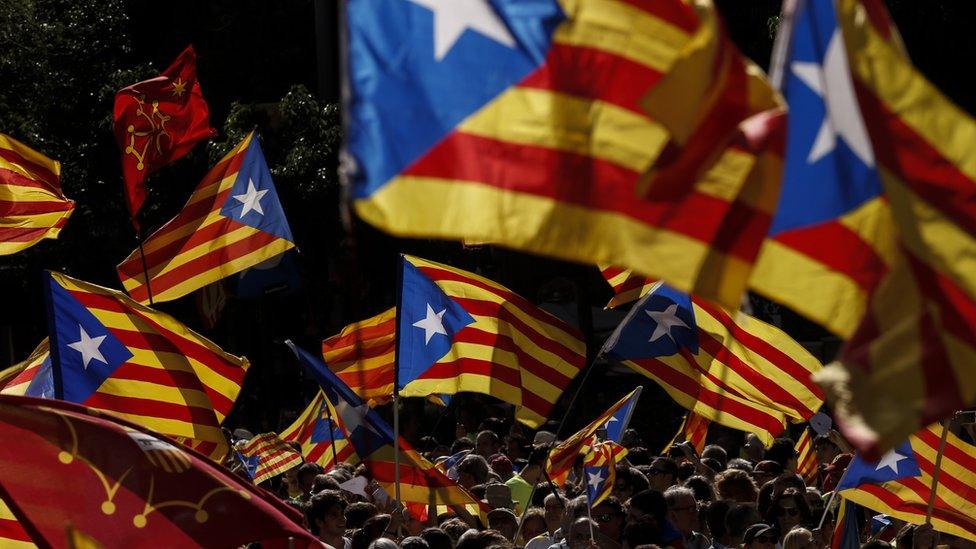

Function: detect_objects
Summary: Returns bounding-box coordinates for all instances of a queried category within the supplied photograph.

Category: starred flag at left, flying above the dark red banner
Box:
[46,272,248,457]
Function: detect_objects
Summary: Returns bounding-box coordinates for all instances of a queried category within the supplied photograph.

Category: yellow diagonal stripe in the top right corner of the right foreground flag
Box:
[838,0,976,179]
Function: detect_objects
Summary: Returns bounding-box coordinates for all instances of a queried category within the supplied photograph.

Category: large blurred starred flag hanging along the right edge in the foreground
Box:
[757,0,976,457]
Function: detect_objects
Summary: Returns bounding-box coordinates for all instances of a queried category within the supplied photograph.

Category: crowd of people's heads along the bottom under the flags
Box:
[238,408,960,549]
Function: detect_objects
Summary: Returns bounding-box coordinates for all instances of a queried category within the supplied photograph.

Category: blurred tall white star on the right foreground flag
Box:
[791,29,874,166]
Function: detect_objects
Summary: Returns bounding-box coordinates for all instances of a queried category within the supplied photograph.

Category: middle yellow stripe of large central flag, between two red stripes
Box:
[458,87,667,172]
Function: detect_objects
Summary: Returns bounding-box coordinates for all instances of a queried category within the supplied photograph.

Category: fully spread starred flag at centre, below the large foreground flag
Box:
[397,256,586,427]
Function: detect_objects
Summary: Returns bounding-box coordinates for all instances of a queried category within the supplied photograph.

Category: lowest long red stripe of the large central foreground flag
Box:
[404,132,771,261]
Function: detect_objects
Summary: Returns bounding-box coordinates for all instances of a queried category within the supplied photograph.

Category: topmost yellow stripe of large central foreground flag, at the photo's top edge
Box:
[552,0,689,72]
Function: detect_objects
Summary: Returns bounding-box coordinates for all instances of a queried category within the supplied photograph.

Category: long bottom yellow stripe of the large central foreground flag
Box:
[370,177,750,307]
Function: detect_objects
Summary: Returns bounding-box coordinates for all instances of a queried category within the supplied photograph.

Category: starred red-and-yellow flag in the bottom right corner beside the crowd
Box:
[840,424,976,541]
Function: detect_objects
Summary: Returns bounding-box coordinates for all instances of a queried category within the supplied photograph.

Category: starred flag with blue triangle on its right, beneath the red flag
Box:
[118,132,295,303]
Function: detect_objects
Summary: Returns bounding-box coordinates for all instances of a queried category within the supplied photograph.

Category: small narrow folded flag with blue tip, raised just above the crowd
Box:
[546,387,643,486]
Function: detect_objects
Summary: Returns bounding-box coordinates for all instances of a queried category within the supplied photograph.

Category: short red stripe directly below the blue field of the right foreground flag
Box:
[775,221,888,292]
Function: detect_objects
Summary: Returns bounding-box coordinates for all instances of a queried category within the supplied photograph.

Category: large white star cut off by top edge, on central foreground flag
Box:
[402,0,515,61]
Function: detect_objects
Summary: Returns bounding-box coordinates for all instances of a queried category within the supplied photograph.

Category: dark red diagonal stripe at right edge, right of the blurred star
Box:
[854,79,976,234]
